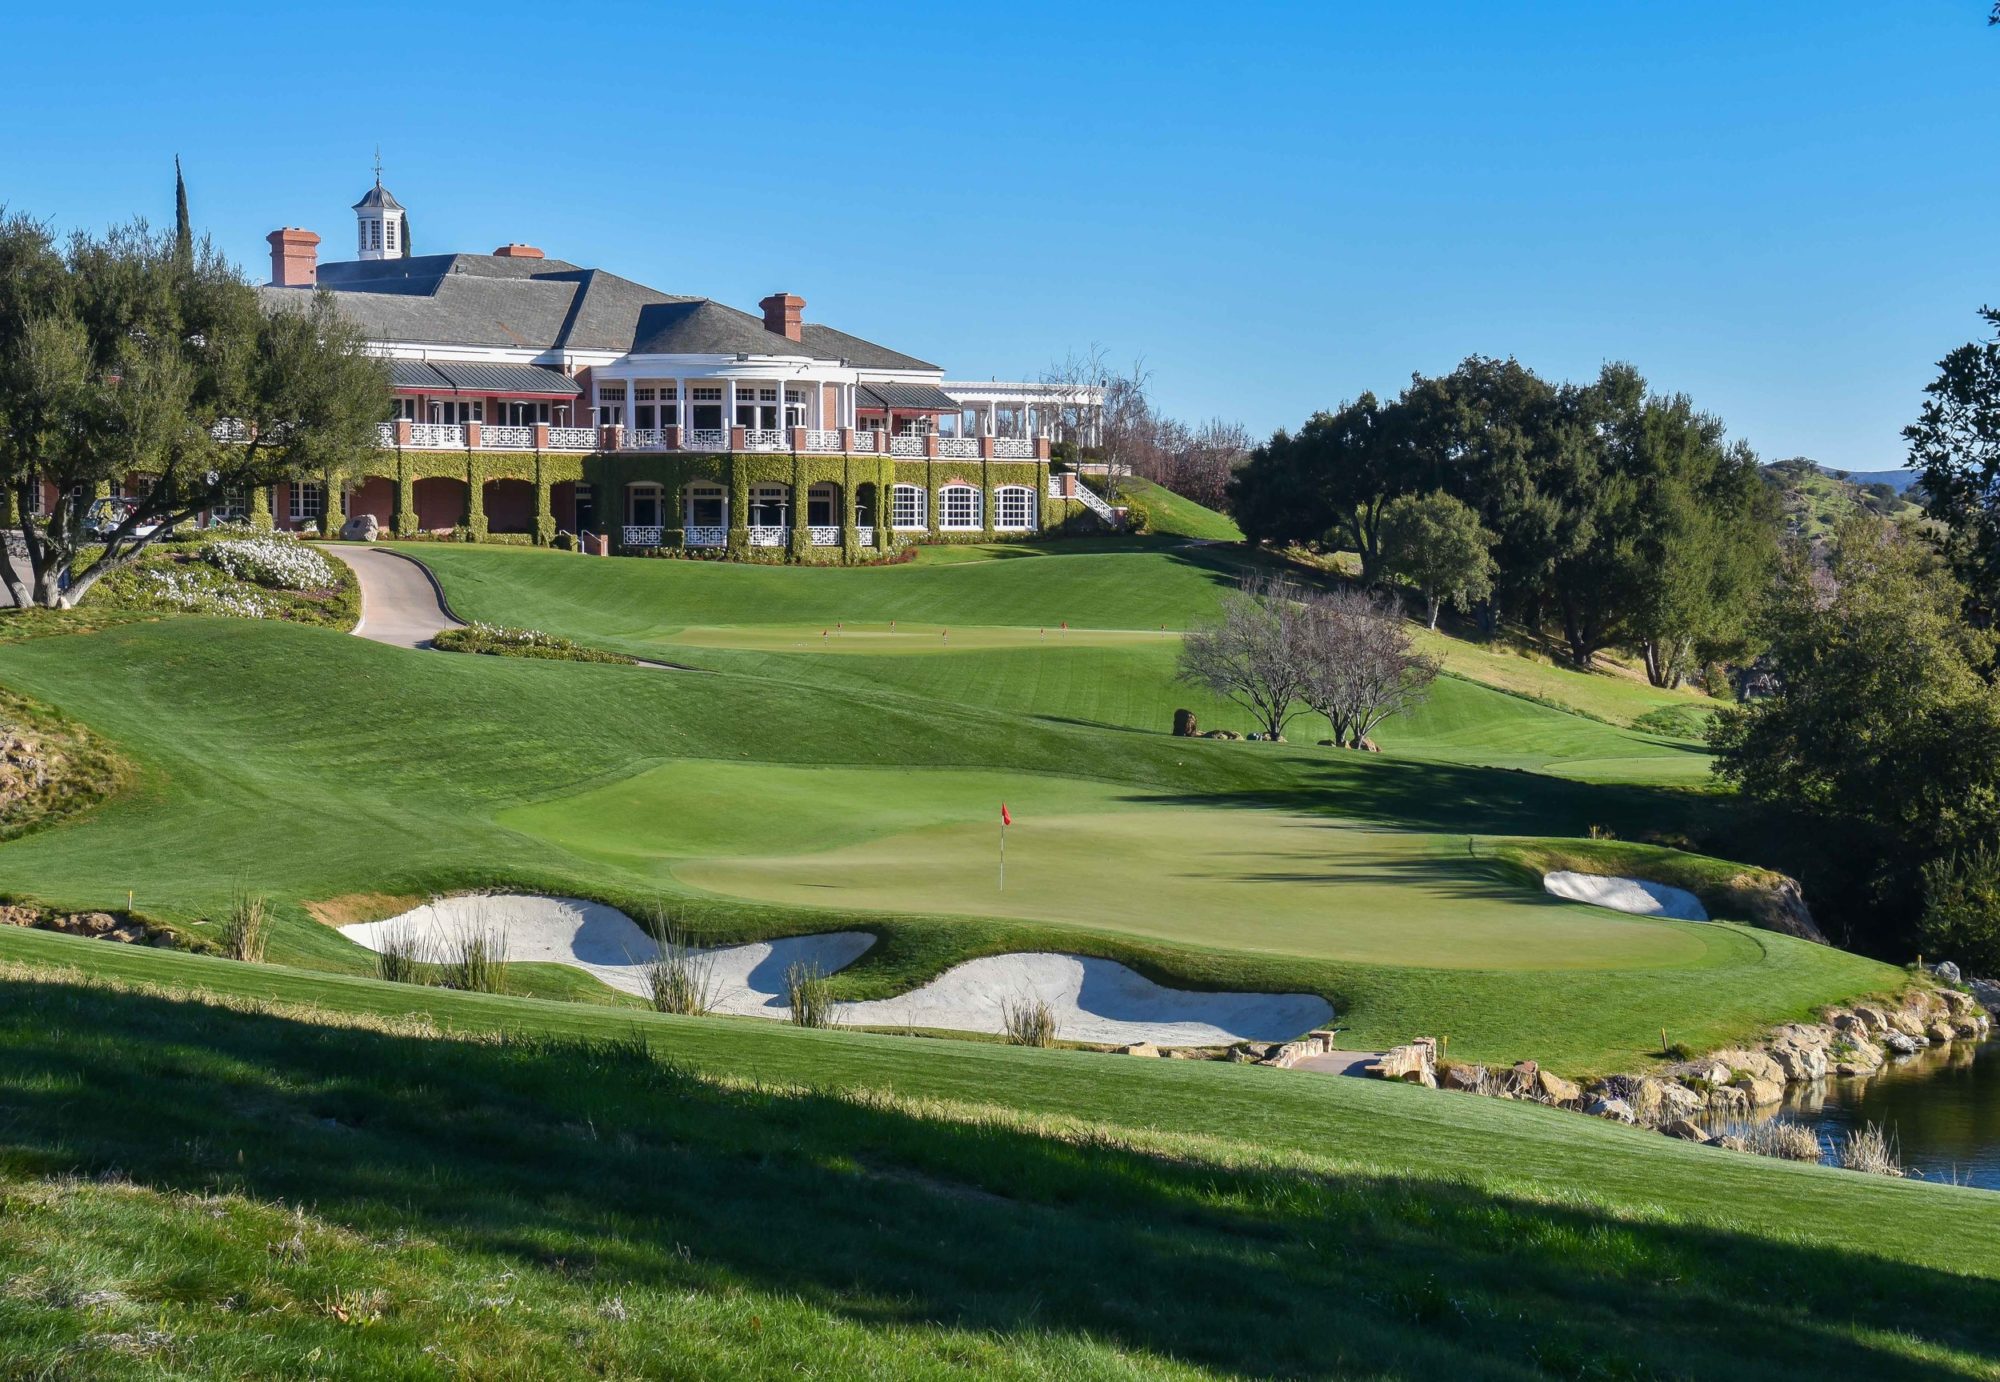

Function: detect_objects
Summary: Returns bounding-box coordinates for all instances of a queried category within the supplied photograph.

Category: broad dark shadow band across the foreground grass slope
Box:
[0,982,2000,1378]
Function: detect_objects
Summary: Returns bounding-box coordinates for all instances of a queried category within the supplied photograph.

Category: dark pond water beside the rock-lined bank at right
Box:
[1774,1040,2000,1190]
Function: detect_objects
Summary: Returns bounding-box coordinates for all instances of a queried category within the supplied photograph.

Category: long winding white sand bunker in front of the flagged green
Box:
[340,894,1334,1046]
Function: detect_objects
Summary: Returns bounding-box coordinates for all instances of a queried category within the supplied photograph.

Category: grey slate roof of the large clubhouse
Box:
[264,249,940,370]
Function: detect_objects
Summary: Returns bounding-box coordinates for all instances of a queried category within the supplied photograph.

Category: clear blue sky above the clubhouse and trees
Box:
[0,0,2000,468]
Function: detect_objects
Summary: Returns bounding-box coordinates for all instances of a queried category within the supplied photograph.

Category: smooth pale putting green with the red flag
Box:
[500,762,1720,970]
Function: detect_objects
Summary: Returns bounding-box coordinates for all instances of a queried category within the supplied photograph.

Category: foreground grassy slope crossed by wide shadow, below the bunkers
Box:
[0,932,2000,1378]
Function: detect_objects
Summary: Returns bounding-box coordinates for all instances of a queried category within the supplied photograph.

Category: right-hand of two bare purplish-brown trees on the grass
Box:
[1298,590,1440,748]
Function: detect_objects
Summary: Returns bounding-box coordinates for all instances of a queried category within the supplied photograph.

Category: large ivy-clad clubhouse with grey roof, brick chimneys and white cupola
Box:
[242,180,1108,562]
